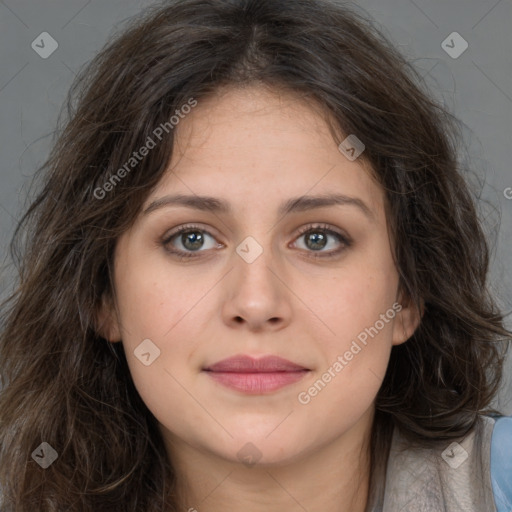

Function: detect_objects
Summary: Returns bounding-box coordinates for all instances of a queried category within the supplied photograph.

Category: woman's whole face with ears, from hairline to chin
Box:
[102,87,417,464]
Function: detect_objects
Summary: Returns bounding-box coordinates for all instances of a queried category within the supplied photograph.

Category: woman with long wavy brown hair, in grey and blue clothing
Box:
[0,0,512,512]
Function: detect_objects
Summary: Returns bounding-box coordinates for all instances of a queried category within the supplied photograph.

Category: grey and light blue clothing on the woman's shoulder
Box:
[372,416,512,512]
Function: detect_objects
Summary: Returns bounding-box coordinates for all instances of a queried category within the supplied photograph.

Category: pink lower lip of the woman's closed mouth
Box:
[206,370,309,395]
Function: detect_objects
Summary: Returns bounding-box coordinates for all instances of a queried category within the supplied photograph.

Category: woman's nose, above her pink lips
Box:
[222,244,293,332]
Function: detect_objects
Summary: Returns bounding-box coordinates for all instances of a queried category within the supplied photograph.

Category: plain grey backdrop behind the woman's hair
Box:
[0,0,512,414]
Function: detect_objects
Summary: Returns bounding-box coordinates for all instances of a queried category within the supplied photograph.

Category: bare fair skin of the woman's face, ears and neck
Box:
[101,85,419,512]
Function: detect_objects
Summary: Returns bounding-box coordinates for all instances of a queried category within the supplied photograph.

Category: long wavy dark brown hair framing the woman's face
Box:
[0,0,510,512]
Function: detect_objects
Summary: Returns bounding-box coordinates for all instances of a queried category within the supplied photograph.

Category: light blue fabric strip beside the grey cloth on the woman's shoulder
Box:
[491,416,512,512]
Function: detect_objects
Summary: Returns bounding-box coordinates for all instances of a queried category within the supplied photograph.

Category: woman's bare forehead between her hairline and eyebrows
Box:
[144,86,384,220]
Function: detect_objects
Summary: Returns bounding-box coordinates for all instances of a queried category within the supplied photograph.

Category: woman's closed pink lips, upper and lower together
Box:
[203,355,310,394]
